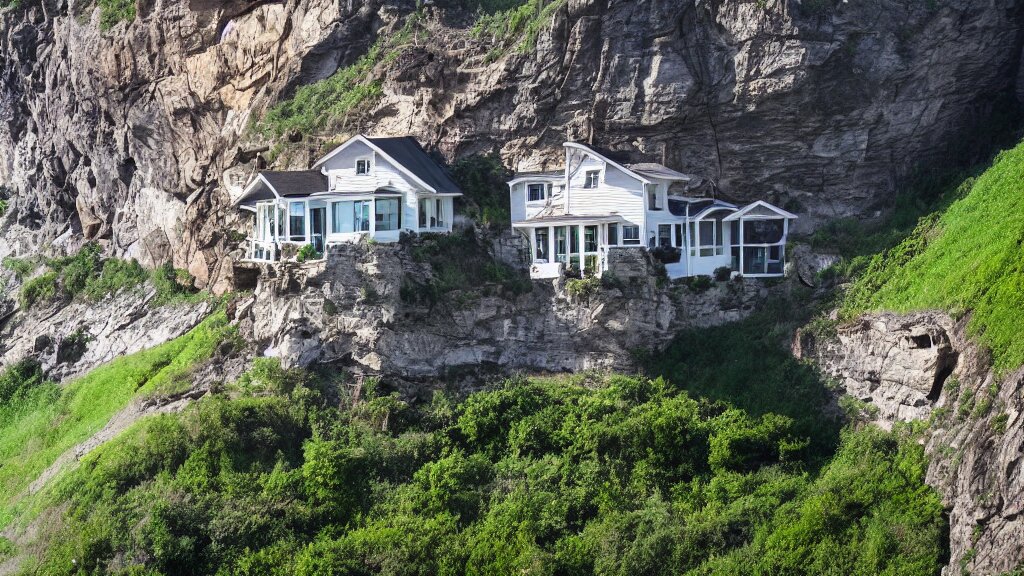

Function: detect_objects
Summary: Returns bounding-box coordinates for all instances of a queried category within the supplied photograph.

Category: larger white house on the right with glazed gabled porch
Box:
[508,142,797,278]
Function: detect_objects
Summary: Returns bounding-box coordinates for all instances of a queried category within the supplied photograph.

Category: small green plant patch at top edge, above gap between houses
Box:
[472,0,565,54]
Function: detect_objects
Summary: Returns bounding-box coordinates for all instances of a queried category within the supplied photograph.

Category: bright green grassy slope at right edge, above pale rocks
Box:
[843,143,1024,370]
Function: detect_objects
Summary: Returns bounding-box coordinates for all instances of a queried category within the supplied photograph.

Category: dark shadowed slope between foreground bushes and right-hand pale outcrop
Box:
[638,294,845,466]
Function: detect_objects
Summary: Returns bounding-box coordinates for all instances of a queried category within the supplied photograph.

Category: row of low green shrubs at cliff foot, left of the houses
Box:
[14,243,201,308]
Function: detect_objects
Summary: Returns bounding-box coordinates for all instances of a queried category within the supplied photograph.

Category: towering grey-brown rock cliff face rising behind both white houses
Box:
[0,0,1021,290]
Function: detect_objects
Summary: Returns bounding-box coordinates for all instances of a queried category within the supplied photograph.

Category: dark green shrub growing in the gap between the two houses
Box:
[452,154,512,229]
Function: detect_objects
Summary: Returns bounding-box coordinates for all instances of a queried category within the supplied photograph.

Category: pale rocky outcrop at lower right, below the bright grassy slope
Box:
[798,313,1024,576]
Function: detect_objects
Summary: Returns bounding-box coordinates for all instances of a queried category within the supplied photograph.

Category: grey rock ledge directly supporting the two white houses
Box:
[237,239,766,381]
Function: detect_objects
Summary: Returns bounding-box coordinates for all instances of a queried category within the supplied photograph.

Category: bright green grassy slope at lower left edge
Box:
[0,313,229,526]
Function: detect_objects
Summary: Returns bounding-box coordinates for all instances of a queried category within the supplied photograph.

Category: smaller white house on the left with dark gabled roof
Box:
[234,134,462,261]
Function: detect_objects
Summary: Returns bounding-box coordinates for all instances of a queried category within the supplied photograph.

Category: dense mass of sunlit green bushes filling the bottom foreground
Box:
[16,349,945,575]
